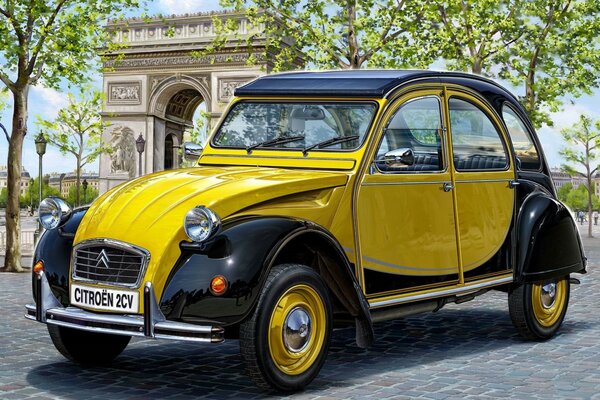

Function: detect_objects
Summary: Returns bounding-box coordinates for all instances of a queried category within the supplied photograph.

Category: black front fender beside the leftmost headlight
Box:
[31,207,88,306]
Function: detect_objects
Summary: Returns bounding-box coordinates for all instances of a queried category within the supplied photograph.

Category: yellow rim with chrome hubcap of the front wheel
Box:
[268,284,327,375]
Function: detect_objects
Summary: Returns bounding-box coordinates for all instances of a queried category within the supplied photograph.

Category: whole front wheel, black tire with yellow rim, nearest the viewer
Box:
[240,264,333,392]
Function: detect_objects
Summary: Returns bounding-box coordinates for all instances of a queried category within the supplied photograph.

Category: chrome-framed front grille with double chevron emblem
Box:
[73,240,149,287]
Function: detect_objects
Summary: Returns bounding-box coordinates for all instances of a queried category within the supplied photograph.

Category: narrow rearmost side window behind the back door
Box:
[502,104,541,171]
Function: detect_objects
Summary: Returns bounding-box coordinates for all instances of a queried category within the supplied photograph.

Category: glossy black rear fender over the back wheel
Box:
[515,182,586,284]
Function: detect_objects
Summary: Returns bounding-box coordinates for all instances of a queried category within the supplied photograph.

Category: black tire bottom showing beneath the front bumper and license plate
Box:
[48,325,131,365]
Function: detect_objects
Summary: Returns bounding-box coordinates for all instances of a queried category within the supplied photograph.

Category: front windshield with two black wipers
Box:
[213,101,376,152]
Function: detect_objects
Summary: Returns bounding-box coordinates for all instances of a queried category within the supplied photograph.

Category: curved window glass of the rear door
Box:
[448,97,508,171]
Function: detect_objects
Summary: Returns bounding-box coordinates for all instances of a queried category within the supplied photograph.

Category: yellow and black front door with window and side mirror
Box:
[357,89,459,297]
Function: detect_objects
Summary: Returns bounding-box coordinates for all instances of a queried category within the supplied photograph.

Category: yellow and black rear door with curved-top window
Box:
[447,91,515,282]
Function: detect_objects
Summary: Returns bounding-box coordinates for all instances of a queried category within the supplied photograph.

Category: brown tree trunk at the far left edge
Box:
[4,85,29,272]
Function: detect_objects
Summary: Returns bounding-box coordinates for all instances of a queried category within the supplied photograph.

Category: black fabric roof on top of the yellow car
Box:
[235,69,508,98]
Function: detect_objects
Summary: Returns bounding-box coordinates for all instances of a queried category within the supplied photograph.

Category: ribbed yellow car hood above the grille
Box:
[75,167,348,250]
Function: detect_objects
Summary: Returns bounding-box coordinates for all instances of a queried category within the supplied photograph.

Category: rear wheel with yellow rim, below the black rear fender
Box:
[508,276,570,340]
